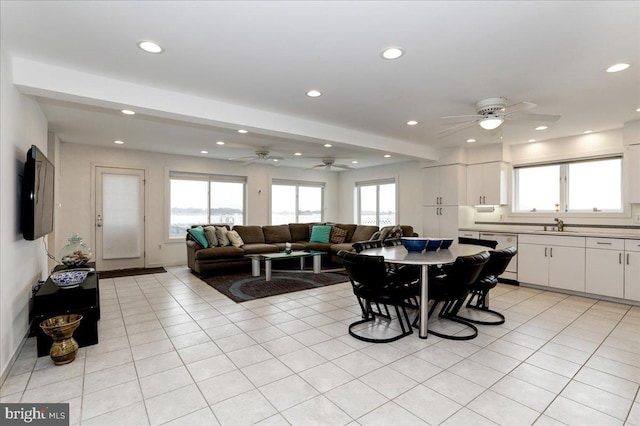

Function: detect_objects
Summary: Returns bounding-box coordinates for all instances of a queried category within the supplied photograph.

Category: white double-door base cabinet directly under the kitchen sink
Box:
[518,234,585,292]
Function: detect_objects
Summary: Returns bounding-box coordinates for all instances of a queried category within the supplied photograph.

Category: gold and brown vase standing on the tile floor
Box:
[40,314,82,365]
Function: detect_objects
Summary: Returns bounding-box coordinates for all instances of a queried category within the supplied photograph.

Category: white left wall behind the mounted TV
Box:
[0,50,49,376]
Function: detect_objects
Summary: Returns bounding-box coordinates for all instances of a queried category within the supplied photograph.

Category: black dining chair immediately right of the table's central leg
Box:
[414,251,489,340]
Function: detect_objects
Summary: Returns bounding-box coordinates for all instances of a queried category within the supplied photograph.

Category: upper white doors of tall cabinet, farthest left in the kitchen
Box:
[422,164,467,206]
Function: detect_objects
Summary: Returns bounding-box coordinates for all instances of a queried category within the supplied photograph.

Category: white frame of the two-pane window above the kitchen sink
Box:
[511,154,628,217]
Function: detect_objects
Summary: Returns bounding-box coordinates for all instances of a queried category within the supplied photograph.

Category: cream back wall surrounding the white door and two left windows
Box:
[55,143,339,267]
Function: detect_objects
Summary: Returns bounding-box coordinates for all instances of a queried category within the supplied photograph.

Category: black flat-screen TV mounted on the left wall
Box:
[21,145,54,240]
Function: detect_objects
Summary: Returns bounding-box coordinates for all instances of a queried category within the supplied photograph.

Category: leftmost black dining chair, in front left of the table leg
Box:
[338,250,413,343]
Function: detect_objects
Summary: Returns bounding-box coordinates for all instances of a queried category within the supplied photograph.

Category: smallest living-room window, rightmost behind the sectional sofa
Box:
[356,179,397,227]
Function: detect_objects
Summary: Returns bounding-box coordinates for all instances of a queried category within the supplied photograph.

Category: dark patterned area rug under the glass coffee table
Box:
[202,272,349,303]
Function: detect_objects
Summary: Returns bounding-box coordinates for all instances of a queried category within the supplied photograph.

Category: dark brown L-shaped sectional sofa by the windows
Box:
[187,223,416,275]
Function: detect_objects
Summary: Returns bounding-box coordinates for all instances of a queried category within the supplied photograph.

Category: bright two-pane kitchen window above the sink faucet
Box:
[514,157,622,213]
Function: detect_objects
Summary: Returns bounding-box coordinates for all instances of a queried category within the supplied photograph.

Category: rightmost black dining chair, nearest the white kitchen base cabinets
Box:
[452,247,518,325]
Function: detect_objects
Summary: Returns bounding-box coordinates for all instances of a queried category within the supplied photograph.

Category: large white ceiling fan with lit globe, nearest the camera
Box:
[440,98,560,136]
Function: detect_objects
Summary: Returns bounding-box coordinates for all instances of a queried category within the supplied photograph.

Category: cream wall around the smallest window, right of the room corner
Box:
[338,161,422,235]
